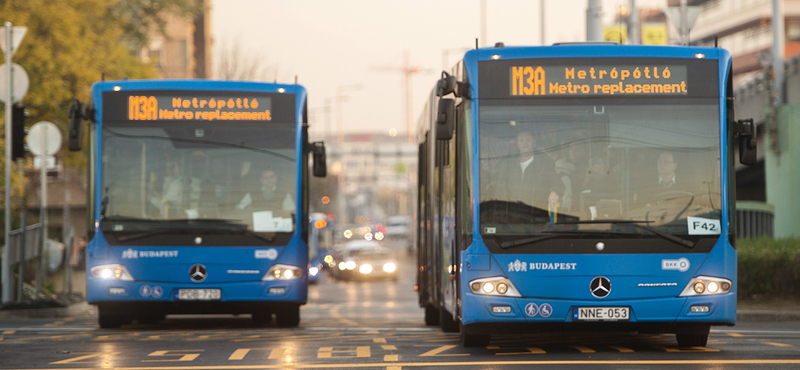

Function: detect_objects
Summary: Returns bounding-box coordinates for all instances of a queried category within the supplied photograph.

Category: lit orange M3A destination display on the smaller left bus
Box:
[127,94,272,121]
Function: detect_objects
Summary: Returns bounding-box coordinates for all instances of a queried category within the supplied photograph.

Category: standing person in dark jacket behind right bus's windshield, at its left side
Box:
[501,131,564,214]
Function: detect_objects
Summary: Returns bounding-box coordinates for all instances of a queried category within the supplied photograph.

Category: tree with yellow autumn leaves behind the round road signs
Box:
[0,0,161,243]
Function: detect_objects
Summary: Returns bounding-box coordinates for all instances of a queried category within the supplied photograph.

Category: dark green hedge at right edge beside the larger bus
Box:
[736,238,800,300]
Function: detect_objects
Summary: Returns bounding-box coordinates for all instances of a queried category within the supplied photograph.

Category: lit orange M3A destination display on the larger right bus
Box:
[508,65,689,97]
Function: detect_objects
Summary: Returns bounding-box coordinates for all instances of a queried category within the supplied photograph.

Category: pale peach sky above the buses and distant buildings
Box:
[211,0,666,140]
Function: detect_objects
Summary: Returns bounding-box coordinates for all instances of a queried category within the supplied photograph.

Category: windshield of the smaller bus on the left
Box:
[101,121,297,237]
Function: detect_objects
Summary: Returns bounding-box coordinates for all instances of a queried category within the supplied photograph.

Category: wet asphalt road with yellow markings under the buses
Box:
[0,260,800,370]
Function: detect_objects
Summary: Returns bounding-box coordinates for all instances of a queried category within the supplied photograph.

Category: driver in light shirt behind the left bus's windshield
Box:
[236,168,295,216]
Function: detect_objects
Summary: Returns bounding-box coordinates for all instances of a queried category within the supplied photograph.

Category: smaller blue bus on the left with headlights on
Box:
[69,80,325,328]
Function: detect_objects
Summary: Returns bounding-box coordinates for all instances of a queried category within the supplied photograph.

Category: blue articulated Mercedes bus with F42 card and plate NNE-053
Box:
[416,44,755,346]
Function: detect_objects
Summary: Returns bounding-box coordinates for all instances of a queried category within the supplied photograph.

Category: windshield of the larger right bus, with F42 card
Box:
[479,98,721,238]
